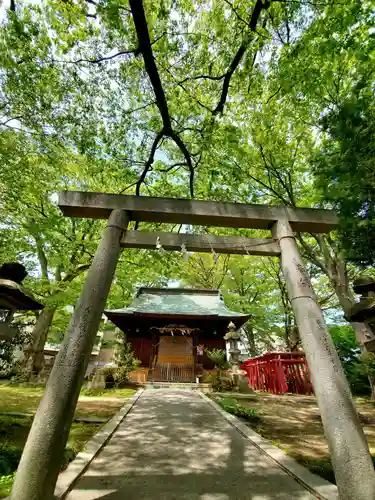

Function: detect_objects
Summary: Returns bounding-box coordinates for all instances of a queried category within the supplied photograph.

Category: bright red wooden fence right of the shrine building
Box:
[241,352,314,394]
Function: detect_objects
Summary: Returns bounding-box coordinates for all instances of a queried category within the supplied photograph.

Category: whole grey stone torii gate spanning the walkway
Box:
[11,191,375,500]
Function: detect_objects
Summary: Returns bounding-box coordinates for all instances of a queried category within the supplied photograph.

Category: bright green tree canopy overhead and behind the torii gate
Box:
[0,0,375,382]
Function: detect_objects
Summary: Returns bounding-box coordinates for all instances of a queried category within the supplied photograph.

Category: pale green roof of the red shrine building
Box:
[104,288,250,326]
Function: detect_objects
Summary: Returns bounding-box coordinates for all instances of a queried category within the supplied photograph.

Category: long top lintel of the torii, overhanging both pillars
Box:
[59,191,338,233]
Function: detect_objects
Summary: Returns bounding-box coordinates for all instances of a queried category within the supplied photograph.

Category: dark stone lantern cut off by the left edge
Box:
[0,262,44,340]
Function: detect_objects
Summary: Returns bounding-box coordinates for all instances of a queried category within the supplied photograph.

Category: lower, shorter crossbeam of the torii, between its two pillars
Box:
[121,231,280,257]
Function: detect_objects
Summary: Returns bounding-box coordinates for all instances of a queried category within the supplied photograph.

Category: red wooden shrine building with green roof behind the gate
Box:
[101,288,250,382]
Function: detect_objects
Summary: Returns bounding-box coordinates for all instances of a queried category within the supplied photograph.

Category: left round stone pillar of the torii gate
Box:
[10,210,129,500]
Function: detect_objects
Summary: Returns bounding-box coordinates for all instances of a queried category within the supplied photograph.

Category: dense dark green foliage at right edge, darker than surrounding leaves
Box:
[314,92,375,266]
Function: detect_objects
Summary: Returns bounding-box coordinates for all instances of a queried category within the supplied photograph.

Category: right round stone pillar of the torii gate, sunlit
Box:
[273,220,375,500]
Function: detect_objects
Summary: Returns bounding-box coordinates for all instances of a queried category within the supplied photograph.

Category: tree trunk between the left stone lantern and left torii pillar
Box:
[27,307,56,375]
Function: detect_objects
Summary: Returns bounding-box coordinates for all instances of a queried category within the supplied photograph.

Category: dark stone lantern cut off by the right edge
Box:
[347,276,375,352]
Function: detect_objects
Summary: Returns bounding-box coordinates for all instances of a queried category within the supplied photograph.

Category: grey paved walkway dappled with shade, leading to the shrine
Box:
[67,389,316,500]
